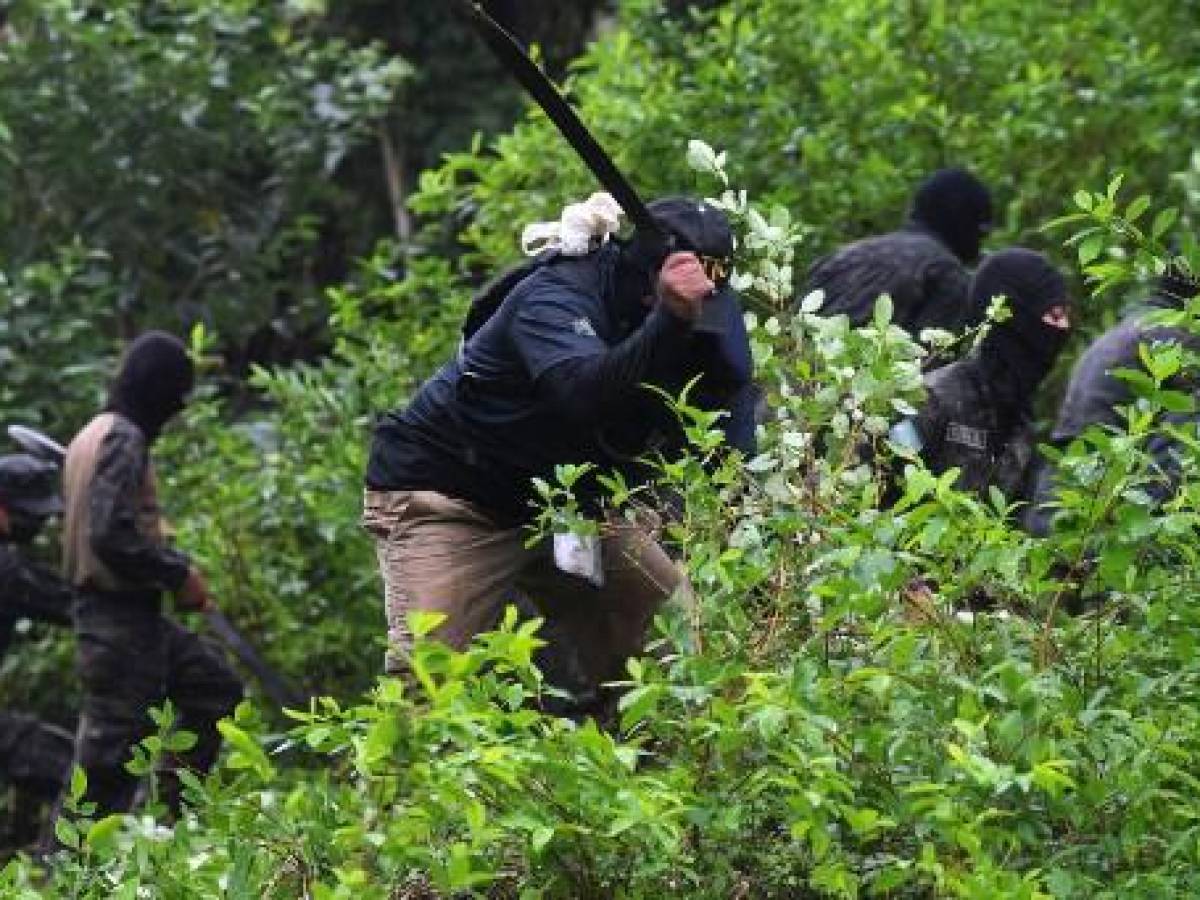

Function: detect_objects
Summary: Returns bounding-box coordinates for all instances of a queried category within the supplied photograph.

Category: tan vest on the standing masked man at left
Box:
[62,413,163,590]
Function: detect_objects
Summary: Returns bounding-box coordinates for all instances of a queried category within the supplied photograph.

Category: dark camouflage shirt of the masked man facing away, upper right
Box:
[804,224,983,336]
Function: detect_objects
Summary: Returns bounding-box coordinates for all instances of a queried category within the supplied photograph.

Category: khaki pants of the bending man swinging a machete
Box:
[362,491,691,686]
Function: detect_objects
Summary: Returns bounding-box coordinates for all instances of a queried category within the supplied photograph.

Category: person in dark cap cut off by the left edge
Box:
[0,454,74,800]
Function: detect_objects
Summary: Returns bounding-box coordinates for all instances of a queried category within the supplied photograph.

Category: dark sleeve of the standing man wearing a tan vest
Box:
[88,427,188,592]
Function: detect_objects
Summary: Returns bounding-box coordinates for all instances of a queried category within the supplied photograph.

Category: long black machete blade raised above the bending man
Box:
[458,0,672,248]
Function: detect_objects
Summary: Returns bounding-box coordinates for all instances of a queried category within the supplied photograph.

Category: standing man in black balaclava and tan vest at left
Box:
[64,331,241,815]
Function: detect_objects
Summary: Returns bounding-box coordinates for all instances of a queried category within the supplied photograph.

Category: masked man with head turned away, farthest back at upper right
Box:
[804,169,991,336]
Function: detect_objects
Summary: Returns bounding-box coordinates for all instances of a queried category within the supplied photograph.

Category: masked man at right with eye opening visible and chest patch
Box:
[892,247,1070,500]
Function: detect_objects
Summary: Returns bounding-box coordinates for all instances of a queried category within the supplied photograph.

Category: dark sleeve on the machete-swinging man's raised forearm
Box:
[523,305,691,425]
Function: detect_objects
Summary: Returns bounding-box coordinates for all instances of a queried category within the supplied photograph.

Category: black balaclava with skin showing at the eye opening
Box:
[971,247,1068,415]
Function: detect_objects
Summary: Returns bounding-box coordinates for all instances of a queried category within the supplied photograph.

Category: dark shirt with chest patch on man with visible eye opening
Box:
[916,356,1034,500]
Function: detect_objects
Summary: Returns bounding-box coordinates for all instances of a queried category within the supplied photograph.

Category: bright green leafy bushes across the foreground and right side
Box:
[7,0,1200,898]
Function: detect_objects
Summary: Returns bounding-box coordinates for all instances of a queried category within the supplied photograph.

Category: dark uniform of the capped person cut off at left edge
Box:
[0,544,73,798]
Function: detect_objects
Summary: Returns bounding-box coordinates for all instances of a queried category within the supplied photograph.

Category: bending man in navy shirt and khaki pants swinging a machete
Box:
[364,194,754,705]
